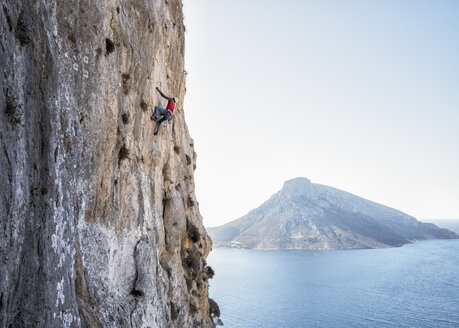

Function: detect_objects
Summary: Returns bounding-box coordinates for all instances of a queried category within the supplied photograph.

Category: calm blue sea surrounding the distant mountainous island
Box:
[207,221,459,328]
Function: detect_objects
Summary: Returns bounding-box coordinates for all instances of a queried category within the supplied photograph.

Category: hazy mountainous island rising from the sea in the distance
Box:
[208,178,459,249]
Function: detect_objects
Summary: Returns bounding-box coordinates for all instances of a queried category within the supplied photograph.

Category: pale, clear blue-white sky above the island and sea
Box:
[183,0,459,227]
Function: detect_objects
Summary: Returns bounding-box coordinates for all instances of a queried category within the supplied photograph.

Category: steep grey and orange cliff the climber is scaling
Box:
[0,0,214,328]
